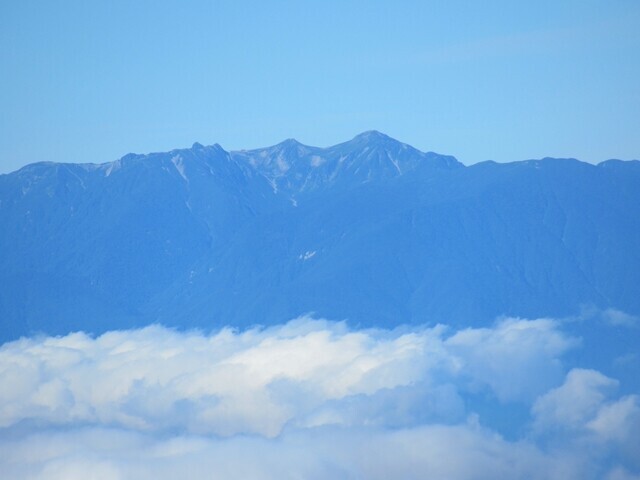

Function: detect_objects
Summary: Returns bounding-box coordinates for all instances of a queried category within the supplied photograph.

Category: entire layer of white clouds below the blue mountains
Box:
[0,318,640,479]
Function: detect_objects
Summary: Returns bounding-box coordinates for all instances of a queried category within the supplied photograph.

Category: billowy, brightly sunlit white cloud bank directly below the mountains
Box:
[0,318,571,436]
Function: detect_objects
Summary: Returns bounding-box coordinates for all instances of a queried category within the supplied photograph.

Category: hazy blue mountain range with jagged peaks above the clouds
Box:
[0,132,640,340]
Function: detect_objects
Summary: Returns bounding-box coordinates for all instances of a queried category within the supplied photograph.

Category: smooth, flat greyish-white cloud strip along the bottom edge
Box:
[0,424,595,480]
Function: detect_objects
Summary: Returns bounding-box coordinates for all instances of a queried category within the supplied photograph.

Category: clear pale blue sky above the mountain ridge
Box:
[0,0,640,172]
